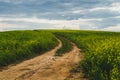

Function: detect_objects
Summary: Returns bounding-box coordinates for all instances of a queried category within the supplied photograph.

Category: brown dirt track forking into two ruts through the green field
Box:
[0,40,85,80]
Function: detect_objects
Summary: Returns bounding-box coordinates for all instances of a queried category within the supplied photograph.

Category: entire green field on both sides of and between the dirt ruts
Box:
[0,30,120,80]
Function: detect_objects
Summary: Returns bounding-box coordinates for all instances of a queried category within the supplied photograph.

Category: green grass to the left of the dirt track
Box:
[0,31,58,66]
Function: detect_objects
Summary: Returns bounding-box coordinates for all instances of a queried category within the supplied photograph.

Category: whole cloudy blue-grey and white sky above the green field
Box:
[0,0,120,31]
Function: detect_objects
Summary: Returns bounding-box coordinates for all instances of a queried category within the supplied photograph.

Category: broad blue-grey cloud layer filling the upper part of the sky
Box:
[0,0,120,19]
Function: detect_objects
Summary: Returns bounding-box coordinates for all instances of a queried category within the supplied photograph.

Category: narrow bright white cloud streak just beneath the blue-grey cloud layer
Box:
[0,17,102,24]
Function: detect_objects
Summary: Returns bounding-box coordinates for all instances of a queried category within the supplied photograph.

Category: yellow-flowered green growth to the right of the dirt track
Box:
[57,31,120,80]
